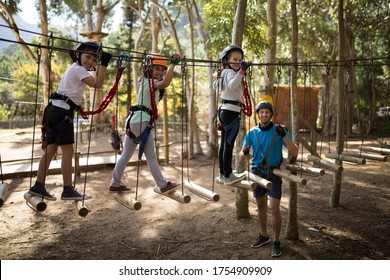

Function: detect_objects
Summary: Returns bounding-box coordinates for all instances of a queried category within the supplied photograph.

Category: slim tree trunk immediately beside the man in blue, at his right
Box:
[286,0,299,240]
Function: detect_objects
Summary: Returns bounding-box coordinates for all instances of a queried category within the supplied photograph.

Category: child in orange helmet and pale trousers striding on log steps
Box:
[109,54,180,193]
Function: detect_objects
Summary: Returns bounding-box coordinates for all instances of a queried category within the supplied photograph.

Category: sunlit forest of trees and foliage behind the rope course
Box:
[0,0,390,241]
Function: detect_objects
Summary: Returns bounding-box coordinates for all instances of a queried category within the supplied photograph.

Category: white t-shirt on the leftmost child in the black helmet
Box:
[52,62,92,110]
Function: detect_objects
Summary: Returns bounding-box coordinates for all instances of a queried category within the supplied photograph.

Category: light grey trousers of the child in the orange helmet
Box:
[111,122,167,188]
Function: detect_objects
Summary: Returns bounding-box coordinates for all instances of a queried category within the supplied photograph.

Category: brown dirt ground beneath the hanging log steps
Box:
[0,127,390,260]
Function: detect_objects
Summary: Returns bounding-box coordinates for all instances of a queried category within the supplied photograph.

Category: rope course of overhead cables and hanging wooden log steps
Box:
[0,24,390,212]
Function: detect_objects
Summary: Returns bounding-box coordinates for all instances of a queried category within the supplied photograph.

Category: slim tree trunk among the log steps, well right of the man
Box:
[330,0,345,207]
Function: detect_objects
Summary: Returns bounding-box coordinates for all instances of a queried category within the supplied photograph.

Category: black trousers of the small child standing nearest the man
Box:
[218,110,240,177]
